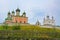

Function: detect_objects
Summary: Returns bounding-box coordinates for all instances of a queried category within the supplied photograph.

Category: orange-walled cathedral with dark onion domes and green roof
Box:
[4,8,28,24]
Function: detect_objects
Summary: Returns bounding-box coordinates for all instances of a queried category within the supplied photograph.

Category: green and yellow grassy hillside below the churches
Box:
[0,25,60,38]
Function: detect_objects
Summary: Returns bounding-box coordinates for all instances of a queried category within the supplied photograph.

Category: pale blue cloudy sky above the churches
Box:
[0,0,60,25]
